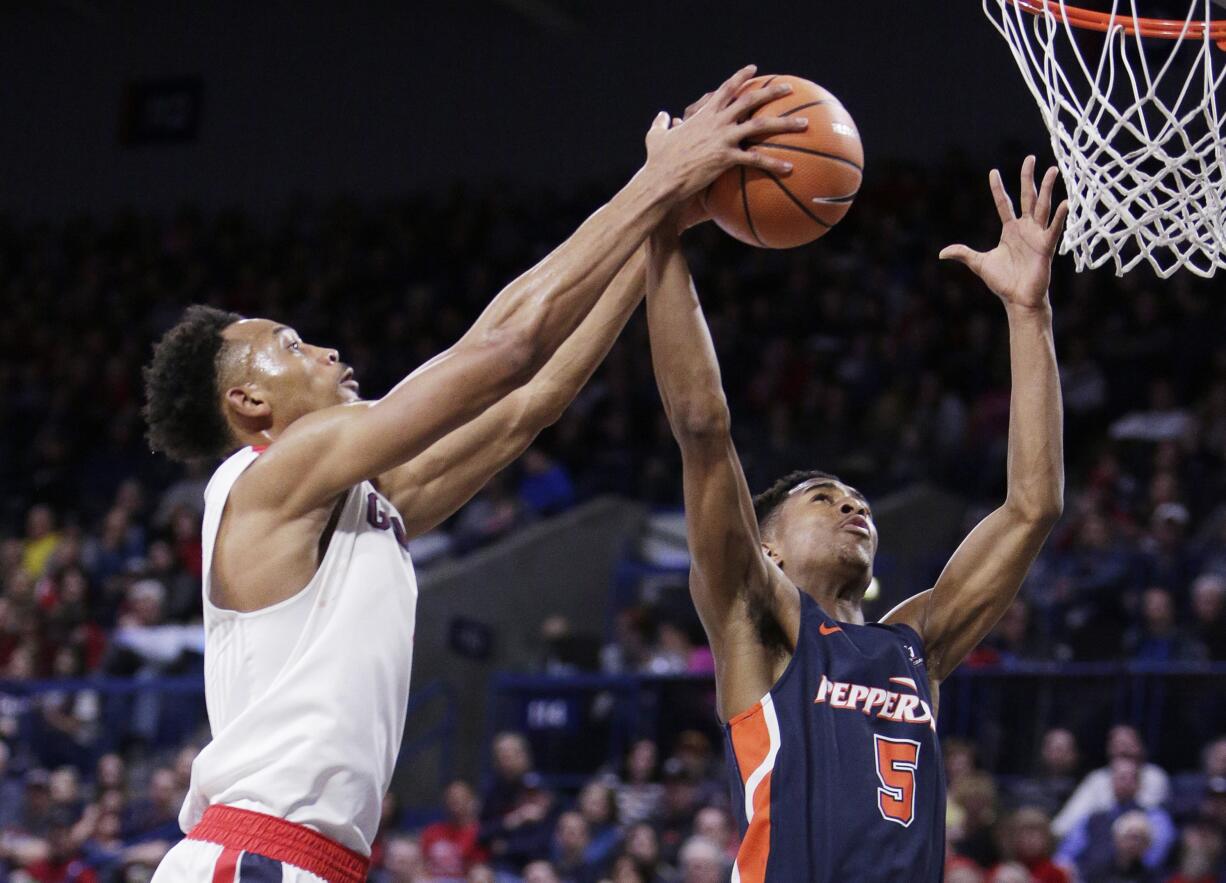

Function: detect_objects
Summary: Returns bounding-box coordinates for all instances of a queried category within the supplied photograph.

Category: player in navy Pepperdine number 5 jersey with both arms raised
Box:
[647,157,1068,883]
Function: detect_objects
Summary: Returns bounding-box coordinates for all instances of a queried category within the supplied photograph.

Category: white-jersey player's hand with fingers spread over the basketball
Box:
[646,65,808,200]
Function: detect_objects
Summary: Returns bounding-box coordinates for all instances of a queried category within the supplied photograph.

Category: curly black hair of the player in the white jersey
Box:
[143,304,243,462]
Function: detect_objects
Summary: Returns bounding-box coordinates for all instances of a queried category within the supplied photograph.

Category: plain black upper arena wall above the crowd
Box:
[0,0,1047,218]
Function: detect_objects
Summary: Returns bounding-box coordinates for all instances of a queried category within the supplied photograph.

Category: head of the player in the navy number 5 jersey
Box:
[771,478,877,587]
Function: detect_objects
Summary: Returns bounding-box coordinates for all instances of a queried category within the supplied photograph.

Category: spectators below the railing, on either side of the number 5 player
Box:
[362,725,1226,883]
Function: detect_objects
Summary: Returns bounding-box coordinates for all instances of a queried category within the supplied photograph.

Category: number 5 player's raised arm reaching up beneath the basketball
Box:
[647,219,799,720]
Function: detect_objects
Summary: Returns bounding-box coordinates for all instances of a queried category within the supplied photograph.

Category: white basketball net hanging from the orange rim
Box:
[983,0,1226,277]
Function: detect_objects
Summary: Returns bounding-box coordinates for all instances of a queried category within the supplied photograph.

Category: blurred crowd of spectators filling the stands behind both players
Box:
[0,157,1226,883]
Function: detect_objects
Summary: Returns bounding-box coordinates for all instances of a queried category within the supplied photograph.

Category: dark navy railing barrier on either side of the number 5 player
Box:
[490,662,1226,789]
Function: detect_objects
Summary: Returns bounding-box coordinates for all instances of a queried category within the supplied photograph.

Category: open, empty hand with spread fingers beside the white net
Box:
[940,156,1069,309]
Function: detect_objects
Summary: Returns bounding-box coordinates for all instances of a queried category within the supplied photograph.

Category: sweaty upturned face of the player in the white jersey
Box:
[224,319,358,423]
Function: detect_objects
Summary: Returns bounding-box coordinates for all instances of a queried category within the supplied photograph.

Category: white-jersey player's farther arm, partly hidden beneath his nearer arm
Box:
[379,248,646,536]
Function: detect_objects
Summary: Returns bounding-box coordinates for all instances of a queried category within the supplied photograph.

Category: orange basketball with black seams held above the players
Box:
[705,75,864,248]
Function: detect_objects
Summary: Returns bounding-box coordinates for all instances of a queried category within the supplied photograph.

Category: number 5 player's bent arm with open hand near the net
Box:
[885,157,1068,682]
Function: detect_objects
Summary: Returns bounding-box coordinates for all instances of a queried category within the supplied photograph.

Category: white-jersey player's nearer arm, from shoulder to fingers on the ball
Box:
[235,67,798,518]
